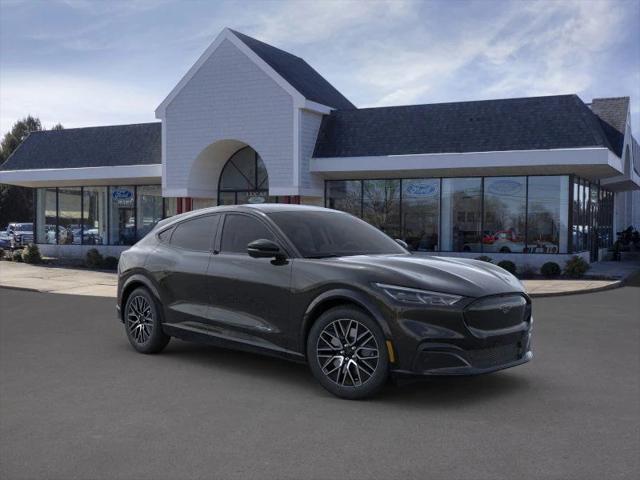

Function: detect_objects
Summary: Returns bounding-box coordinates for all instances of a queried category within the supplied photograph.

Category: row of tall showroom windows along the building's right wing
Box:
[325,175,613,255]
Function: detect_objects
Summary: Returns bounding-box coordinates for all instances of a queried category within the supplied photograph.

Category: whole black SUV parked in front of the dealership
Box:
[117,204,532,398]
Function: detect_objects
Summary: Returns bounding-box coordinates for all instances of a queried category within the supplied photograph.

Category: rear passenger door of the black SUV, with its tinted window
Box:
[152,214,221,327]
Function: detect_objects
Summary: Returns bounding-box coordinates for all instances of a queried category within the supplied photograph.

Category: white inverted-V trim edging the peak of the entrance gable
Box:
[155,28,305,119]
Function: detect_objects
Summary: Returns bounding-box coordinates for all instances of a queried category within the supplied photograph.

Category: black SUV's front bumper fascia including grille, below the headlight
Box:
[382,294,533,376]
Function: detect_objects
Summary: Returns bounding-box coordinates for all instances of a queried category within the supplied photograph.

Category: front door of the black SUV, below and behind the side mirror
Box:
[209,213,293,350]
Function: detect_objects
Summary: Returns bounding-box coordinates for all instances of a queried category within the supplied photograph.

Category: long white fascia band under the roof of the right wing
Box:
[310,148,622,175]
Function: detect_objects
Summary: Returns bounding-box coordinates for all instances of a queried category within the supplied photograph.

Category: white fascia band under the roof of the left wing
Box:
[0,163,162,187]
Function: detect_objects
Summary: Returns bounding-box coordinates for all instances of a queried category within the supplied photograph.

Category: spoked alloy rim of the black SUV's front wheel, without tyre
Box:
[316,318,380,387]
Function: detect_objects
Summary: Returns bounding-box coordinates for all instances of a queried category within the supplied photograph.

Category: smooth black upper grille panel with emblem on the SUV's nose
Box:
[464,294,531,330]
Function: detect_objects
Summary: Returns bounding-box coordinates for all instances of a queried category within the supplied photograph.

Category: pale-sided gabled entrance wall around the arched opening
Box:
[163,40,294,196]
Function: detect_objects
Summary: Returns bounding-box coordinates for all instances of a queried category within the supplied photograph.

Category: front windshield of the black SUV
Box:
[269,211,407,258]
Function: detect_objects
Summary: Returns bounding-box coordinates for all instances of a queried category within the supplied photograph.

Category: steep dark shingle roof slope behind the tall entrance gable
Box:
[231,30,356,109]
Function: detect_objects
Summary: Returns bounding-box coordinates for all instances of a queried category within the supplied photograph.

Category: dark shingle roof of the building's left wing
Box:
[0,122,162,170]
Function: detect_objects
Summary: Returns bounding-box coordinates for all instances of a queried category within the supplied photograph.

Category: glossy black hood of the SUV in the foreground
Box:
[335,254,524,297]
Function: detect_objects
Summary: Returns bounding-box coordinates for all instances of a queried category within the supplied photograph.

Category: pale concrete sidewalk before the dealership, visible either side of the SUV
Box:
[0,261,640,298]
